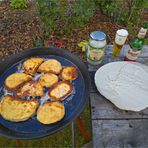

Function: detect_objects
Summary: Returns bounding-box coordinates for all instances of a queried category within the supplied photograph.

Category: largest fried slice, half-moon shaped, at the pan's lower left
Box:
[1,95,38,122]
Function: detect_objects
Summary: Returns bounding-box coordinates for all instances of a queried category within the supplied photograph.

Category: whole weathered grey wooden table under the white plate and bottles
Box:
[89,46,148,148]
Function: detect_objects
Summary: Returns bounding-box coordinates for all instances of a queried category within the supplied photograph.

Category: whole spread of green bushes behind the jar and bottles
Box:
[37,0,147,34]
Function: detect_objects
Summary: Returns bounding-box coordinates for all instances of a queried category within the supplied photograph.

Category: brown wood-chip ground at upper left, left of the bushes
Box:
[0,2,39,58]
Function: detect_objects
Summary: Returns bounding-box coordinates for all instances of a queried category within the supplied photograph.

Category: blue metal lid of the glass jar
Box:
[90,31,106,41]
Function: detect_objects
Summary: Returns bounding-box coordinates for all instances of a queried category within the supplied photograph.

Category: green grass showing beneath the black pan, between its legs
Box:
[0,104,91,148]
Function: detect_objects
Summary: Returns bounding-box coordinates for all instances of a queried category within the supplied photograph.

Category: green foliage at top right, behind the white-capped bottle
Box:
[95,0,147,34]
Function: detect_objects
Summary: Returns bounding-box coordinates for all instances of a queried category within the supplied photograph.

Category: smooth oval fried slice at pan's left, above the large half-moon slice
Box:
[5,73,32,91]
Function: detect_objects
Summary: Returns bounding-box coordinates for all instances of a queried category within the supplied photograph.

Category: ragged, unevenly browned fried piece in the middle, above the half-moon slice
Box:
[17,82,44,97]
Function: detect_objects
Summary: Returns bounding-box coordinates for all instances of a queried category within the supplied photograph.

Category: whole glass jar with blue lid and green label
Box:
[87,31,106,65]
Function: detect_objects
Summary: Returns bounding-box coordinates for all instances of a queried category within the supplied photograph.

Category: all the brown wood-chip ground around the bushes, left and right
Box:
[0,2,148,59]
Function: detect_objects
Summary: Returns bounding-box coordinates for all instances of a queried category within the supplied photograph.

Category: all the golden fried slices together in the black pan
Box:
[0,57,78,124]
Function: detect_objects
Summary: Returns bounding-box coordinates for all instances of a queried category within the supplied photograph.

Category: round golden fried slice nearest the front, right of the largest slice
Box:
[37,102,65,124]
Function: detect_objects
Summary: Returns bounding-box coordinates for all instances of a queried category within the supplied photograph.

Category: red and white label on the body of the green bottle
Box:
[126,47,140,61]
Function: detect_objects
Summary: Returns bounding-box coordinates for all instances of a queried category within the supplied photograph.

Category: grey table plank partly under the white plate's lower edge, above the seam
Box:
[90,92,148,119]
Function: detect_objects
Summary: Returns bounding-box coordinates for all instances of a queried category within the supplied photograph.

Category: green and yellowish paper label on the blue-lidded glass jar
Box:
[87,46,105,62]
